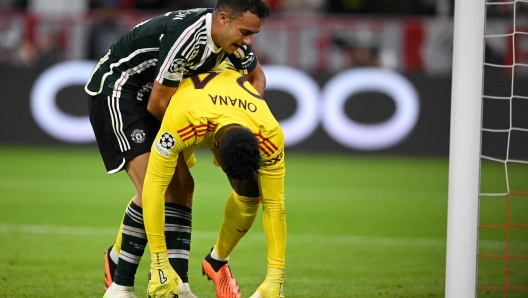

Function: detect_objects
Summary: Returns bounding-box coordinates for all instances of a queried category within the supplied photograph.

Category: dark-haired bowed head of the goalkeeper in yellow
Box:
[218,127,260,180]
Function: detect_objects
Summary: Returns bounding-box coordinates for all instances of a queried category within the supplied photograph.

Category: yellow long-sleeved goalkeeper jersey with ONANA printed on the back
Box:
[143,62,286,263]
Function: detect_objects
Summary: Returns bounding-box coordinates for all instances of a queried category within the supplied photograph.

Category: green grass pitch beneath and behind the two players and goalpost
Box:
[0,147,528,298]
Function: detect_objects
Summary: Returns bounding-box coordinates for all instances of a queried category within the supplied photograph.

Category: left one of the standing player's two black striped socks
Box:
[114,202,147,286]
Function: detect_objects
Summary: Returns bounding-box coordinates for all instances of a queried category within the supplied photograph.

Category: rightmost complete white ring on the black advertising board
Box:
[322,68,420,150]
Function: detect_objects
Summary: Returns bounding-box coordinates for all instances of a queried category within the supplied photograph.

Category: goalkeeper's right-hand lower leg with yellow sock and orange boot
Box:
[202,179,260,297]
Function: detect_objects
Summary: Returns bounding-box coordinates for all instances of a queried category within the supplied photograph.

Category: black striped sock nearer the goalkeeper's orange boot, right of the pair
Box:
[165,203,192,283]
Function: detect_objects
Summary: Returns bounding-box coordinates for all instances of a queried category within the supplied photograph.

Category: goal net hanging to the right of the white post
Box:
[477,0,528,297]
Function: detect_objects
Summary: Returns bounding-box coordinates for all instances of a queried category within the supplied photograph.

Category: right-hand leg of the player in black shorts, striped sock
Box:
[165,149,196,298]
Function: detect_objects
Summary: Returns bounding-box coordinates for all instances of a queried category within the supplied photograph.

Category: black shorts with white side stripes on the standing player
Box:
[88,94,161,174]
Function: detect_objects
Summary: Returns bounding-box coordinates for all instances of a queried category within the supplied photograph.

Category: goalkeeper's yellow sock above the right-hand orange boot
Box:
[214,191,260,259]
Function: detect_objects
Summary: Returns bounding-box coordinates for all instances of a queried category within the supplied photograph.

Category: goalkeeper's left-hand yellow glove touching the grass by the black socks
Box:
[147,252,181,298]
